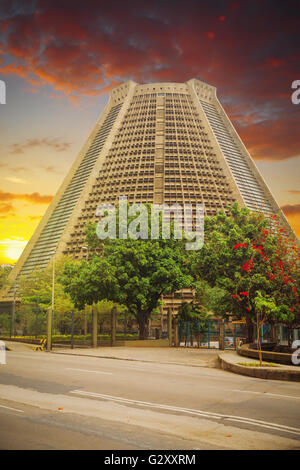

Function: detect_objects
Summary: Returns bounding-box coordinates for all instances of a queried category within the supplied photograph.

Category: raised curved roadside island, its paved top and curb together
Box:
[218,351,300,382]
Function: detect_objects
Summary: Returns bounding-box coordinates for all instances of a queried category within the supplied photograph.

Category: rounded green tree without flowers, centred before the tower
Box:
[61,205,192,339]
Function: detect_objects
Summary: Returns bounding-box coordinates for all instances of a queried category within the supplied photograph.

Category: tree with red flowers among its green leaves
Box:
[191,204,299,342]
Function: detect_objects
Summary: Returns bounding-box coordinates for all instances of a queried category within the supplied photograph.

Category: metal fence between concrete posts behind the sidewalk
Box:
[0,304,300,349]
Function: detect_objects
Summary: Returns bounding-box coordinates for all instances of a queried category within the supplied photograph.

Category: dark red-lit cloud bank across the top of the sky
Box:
[0,0,300,160]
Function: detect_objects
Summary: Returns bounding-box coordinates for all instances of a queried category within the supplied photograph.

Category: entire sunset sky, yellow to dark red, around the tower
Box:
[0,0,300,263]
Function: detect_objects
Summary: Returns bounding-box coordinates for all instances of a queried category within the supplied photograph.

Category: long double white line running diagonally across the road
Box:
[70,390,300,436]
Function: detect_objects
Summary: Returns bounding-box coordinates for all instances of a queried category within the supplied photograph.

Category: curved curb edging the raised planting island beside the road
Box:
[218,354,300,382]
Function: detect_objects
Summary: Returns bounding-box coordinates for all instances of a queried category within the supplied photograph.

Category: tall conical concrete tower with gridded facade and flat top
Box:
[0,79,295,303]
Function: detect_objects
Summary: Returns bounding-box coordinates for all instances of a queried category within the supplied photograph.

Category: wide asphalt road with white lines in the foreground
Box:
[0,345,300,450]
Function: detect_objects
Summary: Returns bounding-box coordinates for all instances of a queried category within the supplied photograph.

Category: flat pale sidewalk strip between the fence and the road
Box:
[52,347,219,367]
